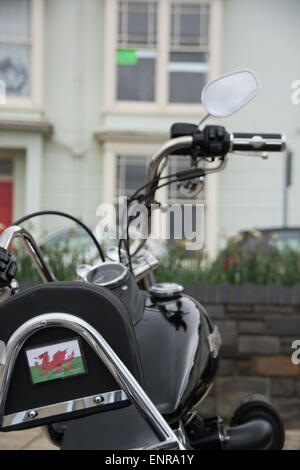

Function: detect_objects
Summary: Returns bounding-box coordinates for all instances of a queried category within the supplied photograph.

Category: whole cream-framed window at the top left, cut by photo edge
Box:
[0,0,43,105]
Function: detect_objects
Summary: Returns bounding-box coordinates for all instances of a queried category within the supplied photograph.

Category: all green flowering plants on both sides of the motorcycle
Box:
[14,231,300,286]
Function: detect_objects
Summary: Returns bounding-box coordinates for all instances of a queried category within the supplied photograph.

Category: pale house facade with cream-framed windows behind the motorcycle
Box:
[0,0,300,255]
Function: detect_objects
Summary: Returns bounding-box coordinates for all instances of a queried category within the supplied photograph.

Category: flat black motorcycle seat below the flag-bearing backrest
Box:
[61,405,159,450]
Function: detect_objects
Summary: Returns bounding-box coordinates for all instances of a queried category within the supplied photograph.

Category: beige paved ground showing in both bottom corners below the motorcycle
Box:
[0,428,300,450]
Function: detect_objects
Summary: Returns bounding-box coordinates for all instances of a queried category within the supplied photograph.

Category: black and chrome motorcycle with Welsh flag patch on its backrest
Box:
[0,70,285,450]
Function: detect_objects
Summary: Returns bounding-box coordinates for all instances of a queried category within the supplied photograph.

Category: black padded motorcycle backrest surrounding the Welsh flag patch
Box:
[0,281,143,430]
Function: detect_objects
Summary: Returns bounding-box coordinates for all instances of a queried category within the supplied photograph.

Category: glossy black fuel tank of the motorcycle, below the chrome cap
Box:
[135,294,217,422]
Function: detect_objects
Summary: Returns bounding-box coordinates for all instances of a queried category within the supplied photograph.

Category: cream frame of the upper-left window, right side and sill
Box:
[0,0,45,111]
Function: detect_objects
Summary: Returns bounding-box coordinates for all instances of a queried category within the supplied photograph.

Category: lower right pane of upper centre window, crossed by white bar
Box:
[169,52,208,103]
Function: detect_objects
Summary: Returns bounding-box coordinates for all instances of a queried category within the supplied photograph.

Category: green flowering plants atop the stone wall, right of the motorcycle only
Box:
[155,237,300,286]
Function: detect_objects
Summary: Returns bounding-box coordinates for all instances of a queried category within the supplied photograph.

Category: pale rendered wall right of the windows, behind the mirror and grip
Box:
[219,0,300,242]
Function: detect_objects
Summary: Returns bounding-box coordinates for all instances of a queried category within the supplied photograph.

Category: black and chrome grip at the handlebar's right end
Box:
[230,133,286,152]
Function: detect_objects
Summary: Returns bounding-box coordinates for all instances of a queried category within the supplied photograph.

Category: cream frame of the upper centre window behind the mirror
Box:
[103,0,222,116]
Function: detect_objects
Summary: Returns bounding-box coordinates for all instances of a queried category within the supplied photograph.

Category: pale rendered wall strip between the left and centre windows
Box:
[43,0,103,231]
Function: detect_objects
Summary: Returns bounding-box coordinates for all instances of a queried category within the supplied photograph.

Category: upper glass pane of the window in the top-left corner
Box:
[0,0,31,42]
